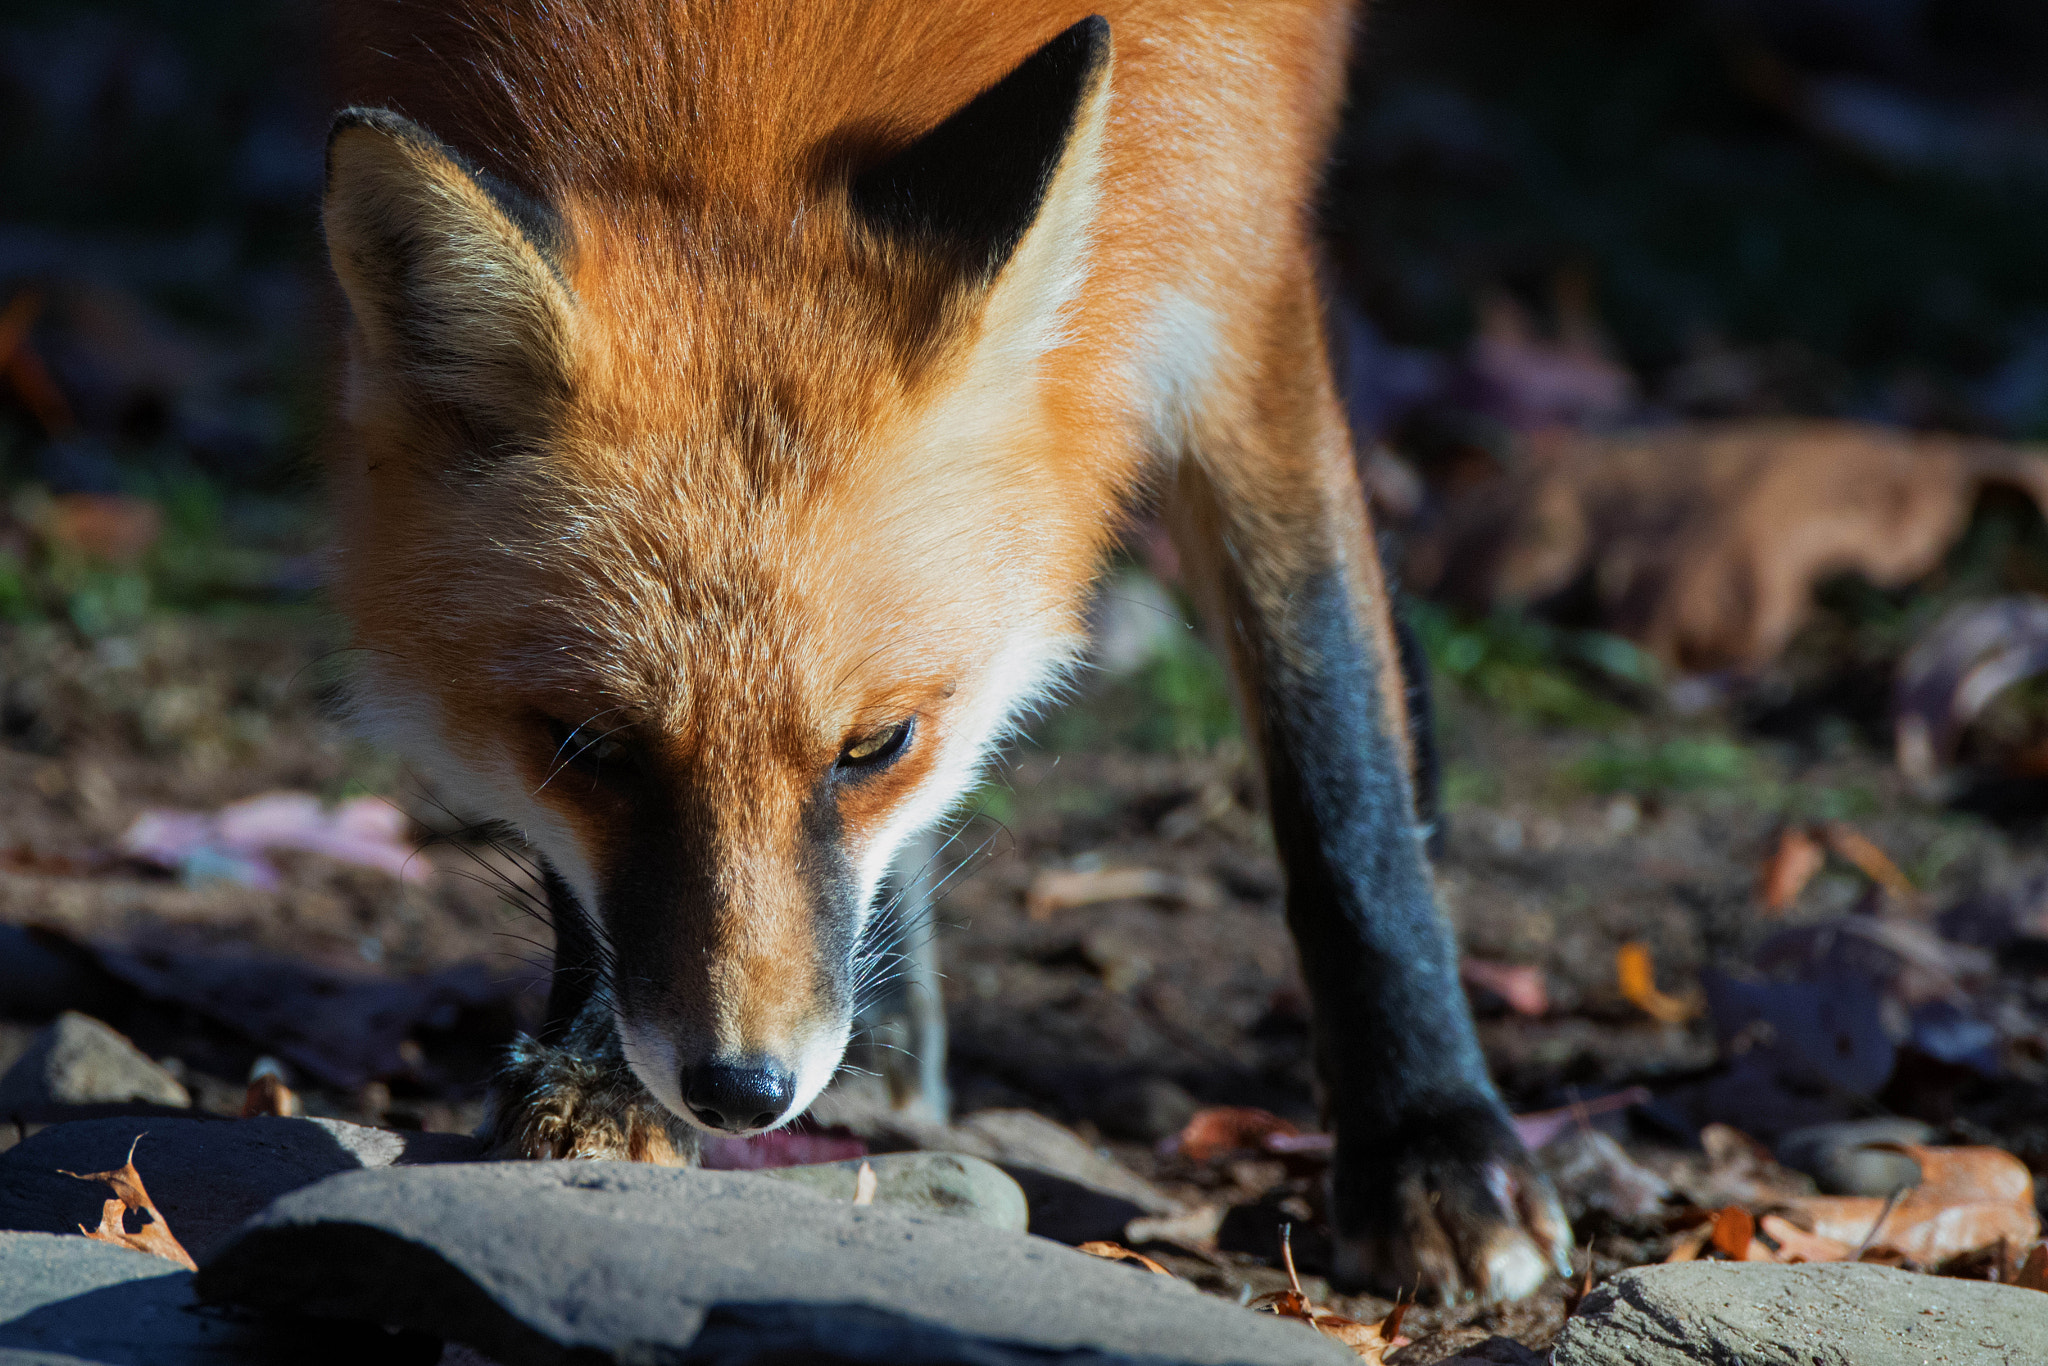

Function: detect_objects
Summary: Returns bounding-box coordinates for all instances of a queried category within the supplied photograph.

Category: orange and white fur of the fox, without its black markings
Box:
[328,0,1405,1138]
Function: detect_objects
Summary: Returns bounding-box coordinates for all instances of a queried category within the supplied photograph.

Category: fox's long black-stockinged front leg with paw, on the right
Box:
[1167,289,1571,1300]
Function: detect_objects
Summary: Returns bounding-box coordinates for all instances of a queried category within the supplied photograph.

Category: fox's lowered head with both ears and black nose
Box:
[326,18,1108,1133]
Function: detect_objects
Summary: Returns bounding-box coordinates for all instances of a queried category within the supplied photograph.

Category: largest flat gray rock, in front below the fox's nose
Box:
[199,1161,1354,1366]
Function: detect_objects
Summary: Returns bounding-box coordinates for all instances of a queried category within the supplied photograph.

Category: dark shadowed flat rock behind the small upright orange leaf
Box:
[0,1118,481,1257]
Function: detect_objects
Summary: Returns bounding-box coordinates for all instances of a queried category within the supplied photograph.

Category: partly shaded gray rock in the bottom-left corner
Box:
[0,1233,428,1366]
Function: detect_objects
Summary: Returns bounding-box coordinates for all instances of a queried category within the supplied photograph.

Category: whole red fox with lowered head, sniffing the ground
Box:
[324,0,1571,1298]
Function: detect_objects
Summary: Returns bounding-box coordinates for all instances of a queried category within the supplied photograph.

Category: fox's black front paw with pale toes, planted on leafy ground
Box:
[1331,1104,1573,1305]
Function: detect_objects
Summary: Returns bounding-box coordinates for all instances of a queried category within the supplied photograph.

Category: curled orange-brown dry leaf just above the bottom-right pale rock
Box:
[1790,1143,2042,1266]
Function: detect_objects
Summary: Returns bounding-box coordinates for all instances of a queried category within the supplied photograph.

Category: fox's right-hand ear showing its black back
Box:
[852,14,1110,281]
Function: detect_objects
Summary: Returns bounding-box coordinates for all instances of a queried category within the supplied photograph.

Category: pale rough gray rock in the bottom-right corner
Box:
[1552,1262,2048,1366]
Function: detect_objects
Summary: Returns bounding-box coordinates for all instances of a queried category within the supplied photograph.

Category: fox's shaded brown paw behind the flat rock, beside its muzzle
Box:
[479,1038,696,1167]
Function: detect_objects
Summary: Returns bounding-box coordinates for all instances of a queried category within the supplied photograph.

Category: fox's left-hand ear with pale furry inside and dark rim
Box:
[324,109,575,438]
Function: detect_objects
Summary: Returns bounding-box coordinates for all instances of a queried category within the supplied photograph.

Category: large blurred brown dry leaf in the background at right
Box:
[1407,420,2048,672]
